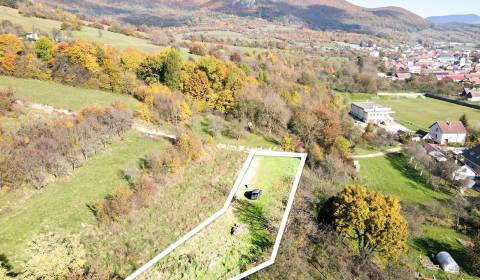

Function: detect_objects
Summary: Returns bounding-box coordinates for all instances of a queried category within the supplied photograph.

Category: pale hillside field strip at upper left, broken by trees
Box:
[0,6,161,52]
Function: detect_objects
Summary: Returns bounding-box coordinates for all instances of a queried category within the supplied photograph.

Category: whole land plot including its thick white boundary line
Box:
[127,151,306,279]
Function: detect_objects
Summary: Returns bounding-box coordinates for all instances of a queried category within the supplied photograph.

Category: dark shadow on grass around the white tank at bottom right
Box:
[413,237,472,274]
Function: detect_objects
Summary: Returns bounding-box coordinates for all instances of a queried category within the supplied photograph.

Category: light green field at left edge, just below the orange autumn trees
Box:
[0,76,138,111]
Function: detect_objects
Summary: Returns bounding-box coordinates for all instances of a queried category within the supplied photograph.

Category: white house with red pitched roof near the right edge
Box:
[428,121,467,145]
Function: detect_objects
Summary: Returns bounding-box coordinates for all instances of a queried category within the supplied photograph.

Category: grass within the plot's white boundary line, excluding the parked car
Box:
[141,157,300,279]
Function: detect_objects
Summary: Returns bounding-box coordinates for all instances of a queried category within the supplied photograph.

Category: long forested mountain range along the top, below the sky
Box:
[44,0,430,35]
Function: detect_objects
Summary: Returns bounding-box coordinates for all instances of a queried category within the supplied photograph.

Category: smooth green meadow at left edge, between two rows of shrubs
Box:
[0,131,164,265]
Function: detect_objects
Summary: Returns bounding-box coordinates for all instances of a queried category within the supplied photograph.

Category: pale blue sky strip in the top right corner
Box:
[347,0,480,17]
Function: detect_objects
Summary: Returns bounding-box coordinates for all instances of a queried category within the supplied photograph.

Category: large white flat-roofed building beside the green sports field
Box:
[350,102,394,124]
